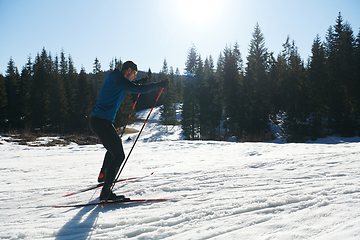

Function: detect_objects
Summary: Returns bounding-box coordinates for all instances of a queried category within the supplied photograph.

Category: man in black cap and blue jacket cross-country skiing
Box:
[90,61,169,201]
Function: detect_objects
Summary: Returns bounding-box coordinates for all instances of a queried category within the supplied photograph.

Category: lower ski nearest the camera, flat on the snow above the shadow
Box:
[53,198,172,208]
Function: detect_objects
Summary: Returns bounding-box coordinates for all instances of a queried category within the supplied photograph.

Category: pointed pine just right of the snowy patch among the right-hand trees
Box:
[269,36,311,141]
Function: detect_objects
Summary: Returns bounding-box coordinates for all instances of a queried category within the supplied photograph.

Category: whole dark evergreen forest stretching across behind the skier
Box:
[0,13,360,142]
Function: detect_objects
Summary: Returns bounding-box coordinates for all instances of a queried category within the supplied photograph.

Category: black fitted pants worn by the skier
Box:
[90,116,125,187]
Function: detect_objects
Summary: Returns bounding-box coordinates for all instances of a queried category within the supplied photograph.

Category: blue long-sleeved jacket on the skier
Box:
[92,70,158,122]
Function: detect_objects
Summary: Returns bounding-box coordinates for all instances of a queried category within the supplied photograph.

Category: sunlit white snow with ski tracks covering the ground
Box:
[0,108,360,240]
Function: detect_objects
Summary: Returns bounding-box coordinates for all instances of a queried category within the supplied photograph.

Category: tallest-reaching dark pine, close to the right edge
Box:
[326,13,357,136]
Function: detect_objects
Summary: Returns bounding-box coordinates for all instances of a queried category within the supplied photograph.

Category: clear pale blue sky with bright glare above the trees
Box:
[0,0,360,75]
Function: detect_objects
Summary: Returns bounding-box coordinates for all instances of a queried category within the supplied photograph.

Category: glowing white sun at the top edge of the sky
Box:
[176,0,221,25]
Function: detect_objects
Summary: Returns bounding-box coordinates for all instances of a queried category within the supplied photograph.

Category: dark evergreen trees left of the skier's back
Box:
[0,48,99,133]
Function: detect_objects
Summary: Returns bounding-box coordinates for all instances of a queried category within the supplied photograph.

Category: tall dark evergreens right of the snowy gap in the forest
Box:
[182,13,360,141]
